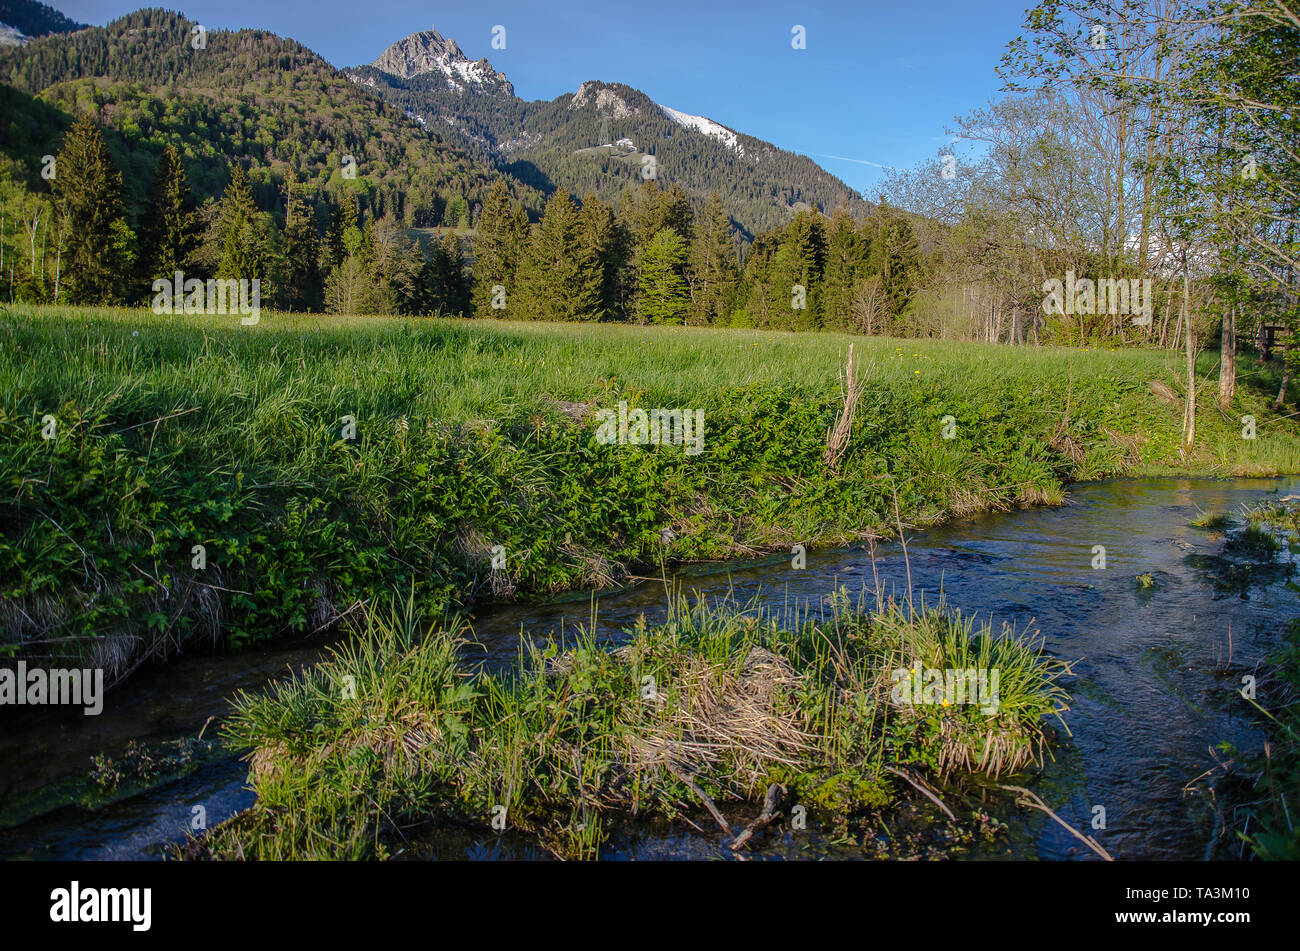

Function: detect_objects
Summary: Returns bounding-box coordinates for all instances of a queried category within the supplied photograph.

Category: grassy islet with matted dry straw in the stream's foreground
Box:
[195,592,1066,859]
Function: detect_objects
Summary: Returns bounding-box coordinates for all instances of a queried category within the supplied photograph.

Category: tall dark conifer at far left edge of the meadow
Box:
[52,114,134,304]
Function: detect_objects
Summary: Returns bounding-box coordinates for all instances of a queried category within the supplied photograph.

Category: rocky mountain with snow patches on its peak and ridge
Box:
[346,30,870,239]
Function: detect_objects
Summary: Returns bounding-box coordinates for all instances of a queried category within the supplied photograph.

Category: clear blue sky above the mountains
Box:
[51,0,1032,197]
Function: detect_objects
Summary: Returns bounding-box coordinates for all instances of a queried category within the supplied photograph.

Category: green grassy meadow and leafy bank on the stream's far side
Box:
[0,307,1300,682]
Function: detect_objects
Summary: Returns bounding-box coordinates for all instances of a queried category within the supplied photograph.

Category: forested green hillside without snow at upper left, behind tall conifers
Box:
[0,9,542,226]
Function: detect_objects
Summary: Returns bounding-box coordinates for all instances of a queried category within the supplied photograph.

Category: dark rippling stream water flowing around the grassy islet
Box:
[0,478,1300,859]
